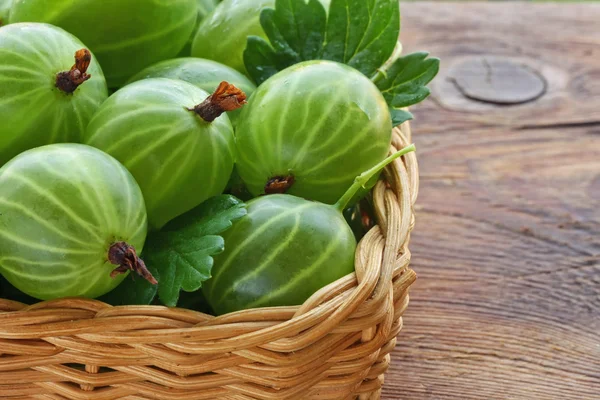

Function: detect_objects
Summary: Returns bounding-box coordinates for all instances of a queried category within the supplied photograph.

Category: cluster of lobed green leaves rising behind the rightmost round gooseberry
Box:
[244,0,440,112]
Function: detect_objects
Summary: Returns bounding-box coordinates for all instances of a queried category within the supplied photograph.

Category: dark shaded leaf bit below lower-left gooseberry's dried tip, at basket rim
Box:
[98,266,160,306]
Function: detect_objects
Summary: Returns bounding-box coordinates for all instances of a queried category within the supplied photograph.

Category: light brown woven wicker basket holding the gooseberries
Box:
[0,124,418,400]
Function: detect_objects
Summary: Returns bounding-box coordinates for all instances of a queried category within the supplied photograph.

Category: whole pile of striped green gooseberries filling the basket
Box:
[0,0,412,314]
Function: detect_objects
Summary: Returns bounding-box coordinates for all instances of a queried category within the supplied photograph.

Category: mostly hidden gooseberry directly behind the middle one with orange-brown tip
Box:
[129,57,256,126]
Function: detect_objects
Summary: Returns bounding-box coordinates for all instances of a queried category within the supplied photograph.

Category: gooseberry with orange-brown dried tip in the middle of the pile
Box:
[84,78,245,230]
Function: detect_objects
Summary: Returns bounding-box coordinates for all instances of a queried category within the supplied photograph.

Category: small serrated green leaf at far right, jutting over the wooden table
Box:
[376,52,440,108]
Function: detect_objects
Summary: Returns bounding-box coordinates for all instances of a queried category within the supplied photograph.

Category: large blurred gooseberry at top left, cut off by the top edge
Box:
[10,0,198,88]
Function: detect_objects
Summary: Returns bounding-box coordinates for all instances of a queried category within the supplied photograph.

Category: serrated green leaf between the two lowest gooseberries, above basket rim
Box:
[144,195,246,307]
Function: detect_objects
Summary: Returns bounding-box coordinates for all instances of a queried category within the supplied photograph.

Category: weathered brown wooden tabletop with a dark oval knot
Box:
[383,2,600,400]
